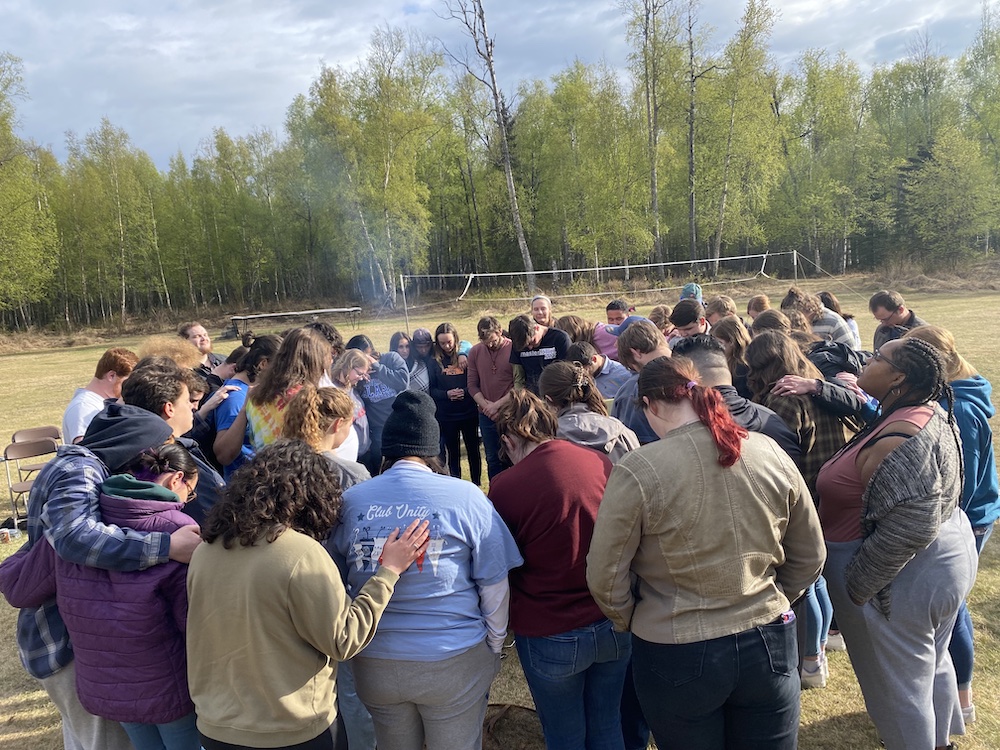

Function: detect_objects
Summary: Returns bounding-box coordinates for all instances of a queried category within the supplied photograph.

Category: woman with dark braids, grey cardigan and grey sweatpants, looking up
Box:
[817,339,977,750]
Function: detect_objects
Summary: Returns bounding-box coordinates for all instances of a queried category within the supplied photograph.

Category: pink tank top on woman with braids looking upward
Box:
[816,406,934,542]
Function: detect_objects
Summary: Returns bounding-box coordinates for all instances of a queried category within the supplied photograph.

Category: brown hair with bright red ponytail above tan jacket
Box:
[637,357,747,466]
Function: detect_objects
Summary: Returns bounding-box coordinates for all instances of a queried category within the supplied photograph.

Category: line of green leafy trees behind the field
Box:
[0,0,1000,327]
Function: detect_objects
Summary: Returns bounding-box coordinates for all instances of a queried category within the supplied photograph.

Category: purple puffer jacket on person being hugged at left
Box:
[56,475,194,724]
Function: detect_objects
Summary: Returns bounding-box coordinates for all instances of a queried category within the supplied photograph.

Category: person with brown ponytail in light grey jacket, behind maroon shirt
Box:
[538,361,639,463]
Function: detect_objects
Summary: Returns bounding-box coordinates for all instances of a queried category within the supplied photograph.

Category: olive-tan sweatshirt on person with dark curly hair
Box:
[187,530,399,747]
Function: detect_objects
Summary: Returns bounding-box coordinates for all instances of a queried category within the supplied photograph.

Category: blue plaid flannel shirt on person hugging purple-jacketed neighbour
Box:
[17,445,170,679]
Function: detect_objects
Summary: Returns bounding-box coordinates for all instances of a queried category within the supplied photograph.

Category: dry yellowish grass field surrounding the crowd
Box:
[0,278,1000,750]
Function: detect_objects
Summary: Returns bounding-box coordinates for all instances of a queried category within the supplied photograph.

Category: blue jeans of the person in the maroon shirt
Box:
[515,620,631,750]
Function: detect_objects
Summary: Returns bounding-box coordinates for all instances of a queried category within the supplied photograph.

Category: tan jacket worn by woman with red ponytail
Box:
[587,422,826,643]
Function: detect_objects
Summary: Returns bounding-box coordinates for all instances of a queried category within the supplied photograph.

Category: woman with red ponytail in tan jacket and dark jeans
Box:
[587,357,824,750]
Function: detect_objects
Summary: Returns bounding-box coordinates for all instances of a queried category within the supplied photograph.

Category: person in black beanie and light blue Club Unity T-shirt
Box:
[328,391,523,748]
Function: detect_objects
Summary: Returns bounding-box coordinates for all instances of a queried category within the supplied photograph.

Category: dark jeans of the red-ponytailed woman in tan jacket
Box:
[632,620,799,750]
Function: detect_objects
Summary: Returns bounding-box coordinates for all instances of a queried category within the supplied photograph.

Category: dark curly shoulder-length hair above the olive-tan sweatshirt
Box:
[201,440,341,549]
